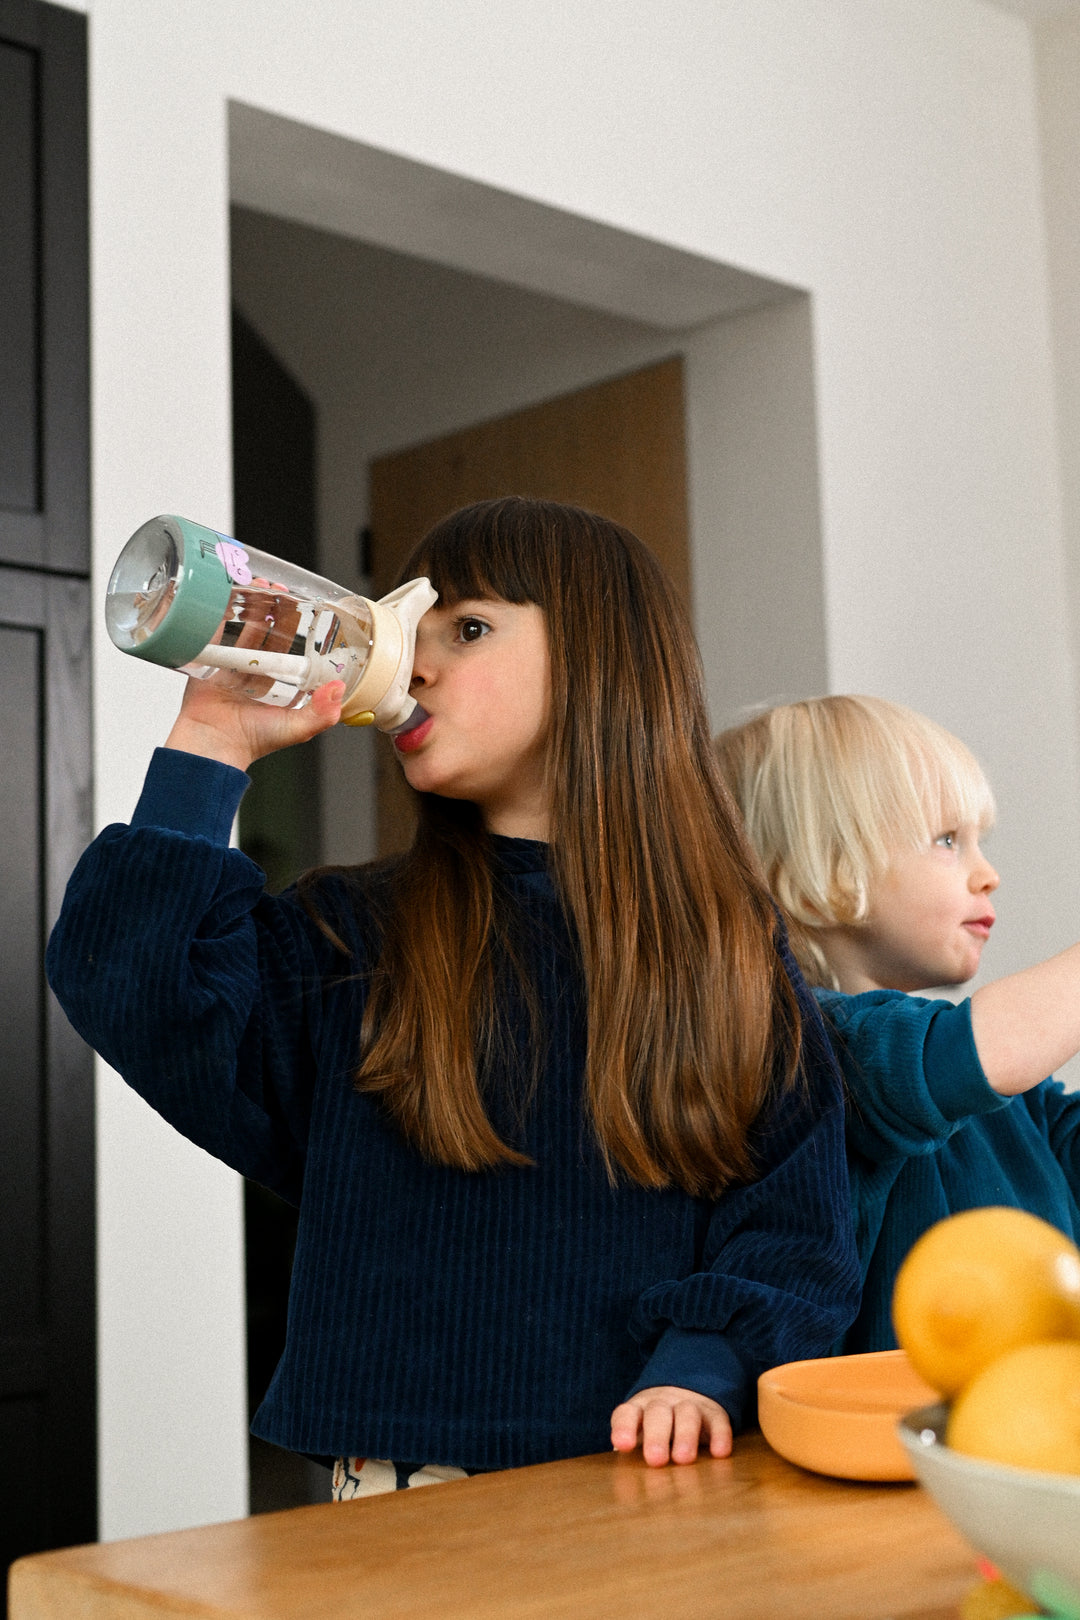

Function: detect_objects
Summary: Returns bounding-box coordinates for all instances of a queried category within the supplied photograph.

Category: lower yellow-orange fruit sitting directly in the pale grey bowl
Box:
[946,1340,1080,1474]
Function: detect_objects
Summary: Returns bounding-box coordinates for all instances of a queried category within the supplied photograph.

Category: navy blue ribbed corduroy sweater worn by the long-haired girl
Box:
[47,750,858,1468]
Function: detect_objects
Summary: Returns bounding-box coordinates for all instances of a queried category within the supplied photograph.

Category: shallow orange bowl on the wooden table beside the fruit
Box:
[758,1349,938,1479]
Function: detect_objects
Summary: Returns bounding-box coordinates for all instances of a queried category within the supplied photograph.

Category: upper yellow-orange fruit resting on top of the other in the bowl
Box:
[892,1207,1080,1398]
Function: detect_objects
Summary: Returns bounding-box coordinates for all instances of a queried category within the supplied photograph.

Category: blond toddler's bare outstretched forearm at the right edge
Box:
[972,944,1080,1097]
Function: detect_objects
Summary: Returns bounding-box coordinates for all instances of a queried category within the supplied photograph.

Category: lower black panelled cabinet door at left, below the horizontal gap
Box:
[0,567,97,1594]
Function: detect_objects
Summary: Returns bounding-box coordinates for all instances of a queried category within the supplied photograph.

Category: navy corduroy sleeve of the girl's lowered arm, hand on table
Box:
[630,948,860,1429]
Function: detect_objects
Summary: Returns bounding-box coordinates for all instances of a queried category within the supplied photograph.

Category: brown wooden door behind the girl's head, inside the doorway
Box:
[371,358,690,854]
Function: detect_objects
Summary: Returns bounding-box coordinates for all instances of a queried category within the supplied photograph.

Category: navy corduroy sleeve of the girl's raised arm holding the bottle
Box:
[47,748,341,1200]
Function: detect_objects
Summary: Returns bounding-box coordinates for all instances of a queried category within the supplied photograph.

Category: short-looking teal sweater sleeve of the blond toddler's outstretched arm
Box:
[818,990,1009,1163]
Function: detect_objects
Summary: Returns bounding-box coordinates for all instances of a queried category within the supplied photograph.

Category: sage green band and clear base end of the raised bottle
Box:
[105,515,236,669]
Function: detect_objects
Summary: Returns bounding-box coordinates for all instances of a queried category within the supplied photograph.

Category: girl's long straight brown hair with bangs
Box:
[310,499,800,1197]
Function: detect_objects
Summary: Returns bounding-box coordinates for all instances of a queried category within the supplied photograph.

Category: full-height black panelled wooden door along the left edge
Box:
[0,0,97,1600]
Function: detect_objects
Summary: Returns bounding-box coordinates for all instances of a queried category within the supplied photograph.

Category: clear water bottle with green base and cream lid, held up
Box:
[105,517,436,734]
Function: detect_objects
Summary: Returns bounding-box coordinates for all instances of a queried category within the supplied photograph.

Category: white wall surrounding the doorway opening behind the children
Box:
[76,0,1080,1536]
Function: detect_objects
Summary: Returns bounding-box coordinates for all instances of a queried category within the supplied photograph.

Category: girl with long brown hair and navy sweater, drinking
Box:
[49,499,857,1494]
